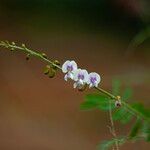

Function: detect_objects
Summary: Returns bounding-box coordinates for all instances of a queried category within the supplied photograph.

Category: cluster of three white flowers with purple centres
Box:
[62,60,101,89]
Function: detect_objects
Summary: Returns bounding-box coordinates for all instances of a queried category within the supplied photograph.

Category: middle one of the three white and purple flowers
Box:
[73,69,89,89]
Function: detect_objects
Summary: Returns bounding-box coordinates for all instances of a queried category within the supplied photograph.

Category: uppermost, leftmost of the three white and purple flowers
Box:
[62,60,77,81]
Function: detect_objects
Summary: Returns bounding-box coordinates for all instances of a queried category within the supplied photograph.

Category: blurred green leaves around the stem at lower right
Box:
[80,80,150,150]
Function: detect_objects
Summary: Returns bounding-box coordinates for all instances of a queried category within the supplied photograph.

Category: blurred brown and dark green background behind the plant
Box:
[0,0,150,150]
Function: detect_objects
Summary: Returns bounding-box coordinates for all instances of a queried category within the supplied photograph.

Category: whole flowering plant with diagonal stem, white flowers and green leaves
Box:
[0,41,150,150]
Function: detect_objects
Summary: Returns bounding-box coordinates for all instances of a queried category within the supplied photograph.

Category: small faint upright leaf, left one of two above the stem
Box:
[112,80,121,95]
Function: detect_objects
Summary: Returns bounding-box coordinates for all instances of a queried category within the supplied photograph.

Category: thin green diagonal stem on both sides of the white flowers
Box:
[0,41,150,121]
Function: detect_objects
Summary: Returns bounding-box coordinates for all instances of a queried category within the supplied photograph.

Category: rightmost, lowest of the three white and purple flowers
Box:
[87,72,101,88]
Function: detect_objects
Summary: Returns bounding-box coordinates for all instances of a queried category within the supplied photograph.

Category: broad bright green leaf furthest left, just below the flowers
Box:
[80,94,115,110]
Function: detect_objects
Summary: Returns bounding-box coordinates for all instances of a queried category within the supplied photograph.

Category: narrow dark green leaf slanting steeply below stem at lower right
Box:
[129,119,142,140]
